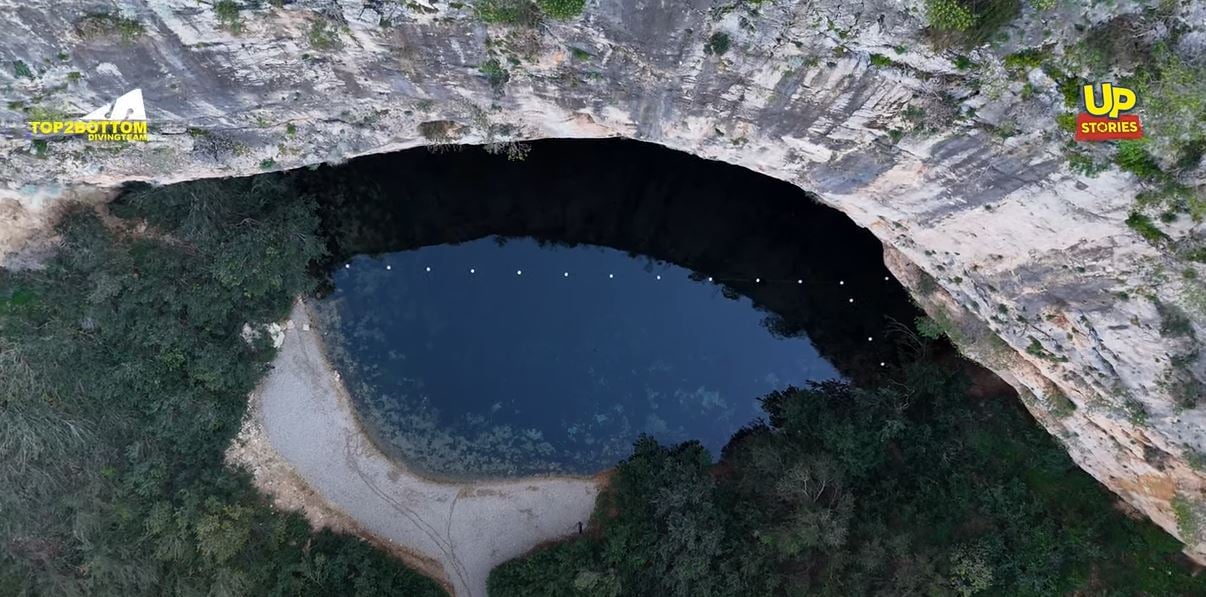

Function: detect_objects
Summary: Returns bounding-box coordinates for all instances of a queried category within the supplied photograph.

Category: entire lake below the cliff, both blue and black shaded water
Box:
[303,141,914,476]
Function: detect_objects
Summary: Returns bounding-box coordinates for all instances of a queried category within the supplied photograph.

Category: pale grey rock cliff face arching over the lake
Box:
[0,0,1206,561]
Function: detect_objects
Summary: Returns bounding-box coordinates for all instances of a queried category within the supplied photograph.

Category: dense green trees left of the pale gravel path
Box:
[0,176,444,596]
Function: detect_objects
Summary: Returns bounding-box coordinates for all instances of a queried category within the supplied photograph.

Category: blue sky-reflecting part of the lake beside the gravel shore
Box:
[320,239,838,476]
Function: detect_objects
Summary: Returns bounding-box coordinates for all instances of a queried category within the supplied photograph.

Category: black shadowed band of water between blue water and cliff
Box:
[294,140,919,480]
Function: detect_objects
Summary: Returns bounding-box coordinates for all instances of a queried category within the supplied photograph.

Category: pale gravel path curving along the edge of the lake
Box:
[228,303,601,597]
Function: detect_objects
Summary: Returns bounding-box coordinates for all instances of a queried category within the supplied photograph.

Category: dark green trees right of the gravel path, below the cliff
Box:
[490,364,1206,597]
